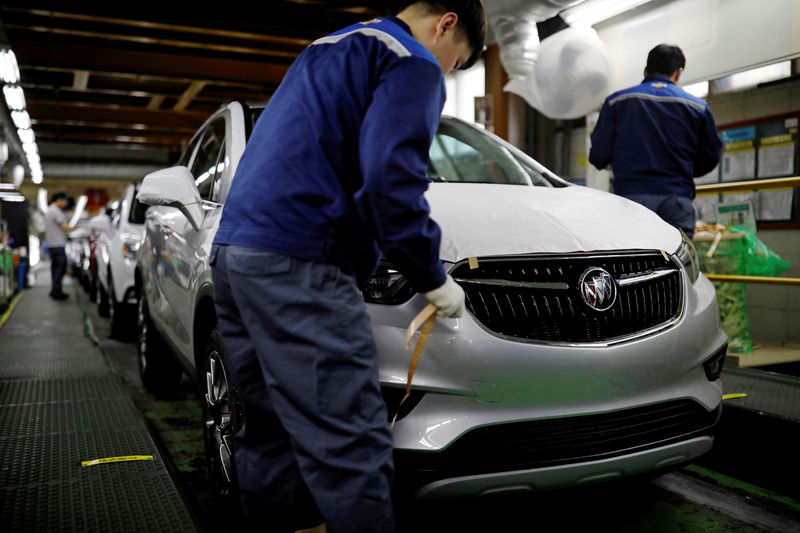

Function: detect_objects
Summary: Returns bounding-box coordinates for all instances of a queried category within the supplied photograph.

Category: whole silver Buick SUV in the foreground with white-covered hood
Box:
[136,98,727,498]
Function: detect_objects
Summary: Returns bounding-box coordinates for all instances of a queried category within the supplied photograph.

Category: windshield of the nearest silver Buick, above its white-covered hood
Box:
[428,119,552,187]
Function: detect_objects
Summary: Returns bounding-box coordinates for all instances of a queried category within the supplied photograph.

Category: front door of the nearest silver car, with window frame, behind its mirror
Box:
[163,110,229,357]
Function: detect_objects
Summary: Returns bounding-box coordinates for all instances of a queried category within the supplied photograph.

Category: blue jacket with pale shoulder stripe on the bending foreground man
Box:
[214,17,445,292]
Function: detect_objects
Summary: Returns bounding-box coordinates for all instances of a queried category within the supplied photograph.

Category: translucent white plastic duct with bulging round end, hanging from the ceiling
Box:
[484,0,611,119]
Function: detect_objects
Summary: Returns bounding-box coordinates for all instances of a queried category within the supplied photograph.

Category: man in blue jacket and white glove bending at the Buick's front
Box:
[210,0,486,533]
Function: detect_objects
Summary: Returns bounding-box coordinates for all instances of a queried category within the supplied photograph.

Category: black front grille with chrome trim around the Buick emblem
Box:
[451,252,683,343]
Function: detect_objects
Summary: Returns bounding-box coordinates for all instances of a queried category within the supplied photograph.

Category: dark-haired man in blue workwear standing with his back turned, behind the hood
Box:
[589,44,722,238]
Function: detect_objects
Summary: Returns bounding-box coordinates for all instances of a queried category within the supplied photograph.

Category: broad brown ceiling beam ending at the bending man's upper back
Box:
[14,39,289,85]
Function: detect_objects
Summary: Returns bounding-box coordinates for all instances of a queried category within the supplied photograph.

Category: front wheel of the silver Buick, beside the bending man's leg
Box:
[200,326,244,510]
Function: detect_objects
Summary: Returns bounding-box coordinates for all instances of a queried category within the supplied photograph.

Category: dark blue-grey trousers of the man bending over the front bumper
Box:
[210,245,394,533]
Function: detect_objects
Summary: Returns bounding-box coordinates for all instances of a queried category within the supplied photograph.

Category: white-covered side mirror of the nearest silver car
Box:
[136,165,203,231]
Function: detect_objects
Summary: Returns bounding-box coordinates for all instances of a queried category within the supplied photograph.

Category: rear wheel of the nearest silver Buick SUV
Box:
[136,295,183,393]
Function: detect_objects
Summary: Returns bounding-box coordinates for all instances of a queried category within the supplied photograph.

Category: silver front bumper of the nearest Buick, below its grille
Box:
[370,270,727,452]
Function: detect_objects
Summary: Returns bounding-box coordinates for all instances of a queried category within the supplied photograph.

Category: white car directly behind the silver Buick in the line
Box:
[95,184,148,339]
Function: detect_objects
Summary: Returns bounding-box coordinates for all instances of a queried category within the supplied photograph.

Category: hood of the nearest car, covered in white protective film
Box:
[425,183,681,262]
